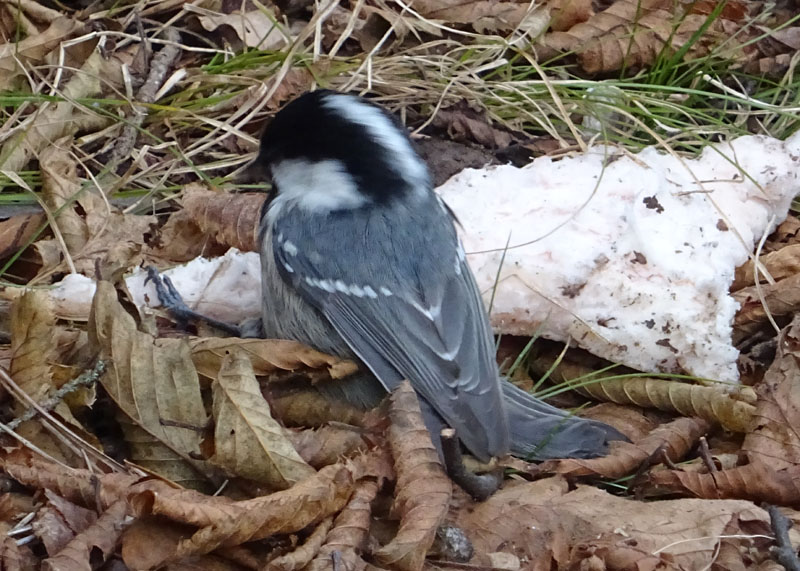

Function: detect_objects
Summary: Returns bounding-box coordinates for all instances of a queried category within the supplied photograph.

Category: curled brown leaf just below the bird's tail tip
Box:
[540,418,709,479]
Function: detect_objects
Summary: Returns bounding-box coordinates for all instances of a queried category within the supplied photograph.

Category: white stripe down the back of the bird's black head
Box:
[322,93,429,187]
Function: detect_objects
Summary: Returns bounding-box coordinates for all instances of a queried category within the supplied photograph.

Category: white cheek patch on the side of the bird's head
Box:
[270,159,368,213]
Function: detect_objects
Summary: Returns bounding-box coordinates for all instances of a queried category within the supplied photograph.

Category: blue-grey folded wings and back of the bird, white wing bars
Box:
[273,201,509,459]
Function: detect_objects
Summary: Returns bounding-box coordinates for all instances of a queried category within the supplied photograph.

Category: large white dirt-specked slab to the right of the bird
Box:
[437,134,800,381]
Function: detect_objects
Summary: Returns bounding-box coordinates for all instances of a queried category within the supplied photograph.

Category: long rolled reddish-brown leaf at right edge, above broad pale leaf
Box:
[650,461,800,508]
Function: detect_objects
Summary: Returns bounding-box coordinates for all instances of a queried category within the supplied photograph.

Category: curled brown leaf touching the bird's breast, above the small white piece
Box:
[183,184,266,252]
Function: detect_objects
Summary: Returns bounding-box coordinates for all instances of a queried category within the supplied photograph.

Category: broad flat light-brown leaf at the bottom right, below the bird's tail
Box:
[457,478,784,569]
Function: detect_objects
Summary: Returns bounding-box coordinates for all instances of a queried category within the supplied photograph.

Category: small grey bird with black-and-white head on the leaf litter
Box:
[253,90,624,460]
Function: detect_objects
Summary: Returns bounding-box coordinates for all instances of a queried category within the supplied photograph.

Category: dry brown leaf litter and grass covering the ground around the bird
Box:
[0,0,800,570]
